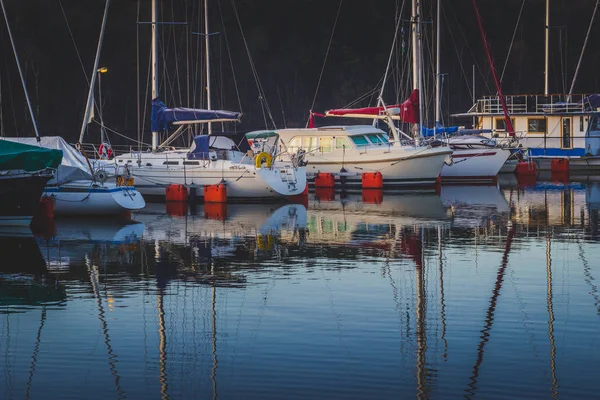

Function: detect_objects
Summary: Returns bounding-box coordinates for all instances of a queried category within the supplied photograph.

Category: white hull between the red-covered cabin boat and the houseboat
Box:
[441,147,510,182]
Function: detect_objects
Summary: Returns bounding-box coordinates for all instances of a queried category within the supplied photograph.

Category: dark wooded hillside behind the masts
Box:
[0,0,600,146]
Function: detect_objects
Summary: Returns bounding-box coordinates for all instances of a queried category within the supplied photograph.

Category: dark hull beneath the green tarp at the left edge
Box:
[0,172,52,226]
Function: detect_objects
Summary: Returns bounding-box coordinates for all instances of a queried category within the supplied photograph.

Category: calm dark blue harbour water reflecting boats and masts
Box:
[0,177,600,399]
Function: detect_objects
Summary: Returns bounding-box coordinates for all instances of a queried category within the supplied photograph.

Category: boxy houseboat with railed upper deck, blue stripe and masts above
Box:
[452,0,600,170]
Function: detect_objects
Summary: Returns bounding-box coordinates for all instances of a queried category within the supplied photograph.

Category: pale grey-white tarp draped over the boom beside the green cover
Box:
[3,136,92,185]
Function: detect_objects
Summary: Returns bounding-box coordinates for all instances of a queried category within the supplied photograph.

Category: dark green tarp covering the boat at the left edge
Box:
[0,139,62,172]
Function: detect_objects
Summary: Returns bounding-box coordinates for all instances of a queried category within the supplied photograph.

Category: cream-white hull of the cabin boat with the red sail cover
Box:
[306,146,449,187]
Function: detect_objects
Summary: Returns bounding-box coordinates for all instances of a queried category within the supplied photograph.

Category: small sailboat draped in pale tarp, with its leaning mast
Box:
[4,0,146,216]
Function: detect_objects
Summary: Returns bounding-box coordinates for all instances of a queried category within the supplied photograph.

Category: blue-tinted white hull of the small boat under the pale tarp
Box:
[44,181,146,216]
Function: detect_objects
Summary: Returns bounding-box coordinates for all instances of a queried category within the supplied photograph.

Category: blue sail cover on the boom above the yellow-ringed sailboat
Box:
[151,97,242,132]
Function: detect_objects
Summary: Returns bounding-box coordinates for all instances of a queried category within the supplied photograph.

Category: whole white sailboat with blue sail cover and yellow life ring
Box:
[101,0,306,200]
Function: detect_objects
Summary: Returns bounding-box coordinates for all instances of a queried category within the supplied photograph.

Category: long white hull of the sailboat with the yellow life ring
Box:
[105,152,306,200]
